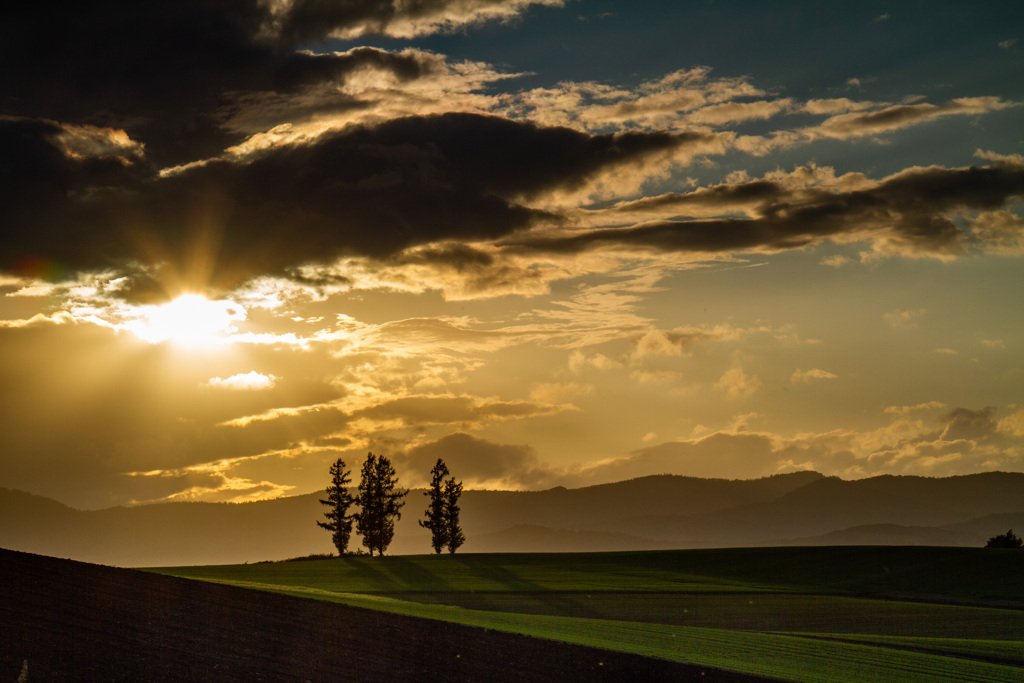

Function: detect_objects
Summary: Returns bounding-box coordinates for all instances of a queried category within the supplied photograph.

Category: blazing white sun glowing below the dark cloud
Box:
[128,294,246,348]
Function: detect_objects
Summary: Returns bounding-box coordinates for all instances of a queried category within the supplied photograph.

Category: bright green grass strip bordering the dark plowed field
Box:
[157,583,1024,683]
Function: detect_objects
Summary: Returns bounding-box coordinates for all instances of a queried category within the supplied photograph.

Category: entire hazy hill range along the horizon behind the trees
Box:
[0,472,1024,566]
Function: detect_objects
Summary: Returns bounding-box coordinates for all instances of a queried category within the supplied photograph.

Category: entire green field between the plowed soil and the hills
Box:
[153,547,1024,681]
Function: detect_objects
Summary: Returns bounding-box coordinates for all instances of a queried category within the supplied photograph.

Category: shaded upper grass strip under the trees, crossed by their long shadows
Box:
[151,546,1024,607]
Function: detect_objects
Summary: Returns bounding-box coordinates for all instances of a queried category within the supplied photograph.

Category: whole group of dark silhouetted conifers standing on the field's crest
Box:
[316,452,466,556]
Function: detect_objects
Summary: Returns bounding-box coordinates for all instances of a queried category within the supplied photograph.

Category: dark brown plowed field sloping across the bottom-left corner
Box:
[0,550,763,683]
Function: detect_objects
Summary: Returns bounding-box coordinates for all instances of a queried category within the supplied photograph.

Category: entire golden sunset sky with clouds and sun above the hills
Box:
[0,0,1024,509]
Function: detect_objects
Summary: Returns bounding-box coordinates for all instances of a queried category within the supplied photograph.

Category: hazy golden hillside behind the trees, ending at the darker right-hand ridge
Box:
[0,472,821,566]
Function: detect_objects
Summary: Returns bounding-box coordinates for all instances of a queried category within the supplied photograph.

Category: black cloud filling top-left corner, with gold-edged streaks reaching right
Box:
[0,0,529,166]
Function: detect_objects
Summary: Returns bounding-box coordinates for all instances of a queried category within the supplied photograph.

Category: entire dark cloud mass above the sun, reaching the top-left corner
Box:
[6,0,561,288]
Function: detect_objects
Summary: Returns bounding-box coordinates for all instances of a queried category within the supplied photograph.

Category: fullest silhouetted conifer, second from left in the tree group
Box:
[355,453,409,555]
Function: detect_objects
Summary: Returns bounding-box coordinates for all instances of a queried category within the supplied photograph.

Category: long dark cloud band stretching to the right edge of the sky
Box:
[510,165,1024,256]
